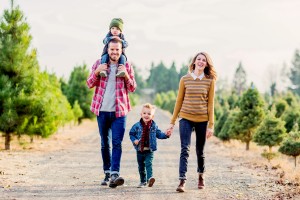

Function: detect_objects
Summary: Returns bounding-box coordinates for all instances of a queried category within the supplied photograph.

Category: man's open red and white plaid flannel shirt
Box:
[86,60,136,117]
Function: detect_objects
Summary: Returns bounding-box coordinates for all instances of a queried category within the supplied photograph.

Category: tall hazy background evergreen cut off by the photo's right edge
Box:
[289,50,300,95]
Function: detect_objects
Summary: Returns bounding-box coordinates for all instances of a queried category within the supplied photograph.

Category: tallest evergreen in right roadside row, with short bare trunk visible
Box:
[231,86,264,150]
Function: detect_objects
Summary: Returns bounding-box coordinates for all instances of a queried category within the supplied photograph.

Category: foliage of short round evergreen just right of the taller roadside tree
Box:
[253,112,286,147]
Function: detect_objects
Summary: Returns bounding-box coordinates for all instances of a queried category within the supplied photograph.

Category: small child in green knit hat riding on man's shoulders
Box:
[99,18,128,77]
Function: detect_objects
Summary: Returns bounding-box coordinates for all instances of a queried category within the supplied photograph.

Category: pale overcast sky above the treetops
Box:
[0,0,300,91]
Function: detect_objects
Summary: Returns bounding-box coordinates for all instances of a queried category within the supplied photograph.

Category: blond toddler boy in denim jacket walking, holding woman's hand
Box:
[129,103,171,188]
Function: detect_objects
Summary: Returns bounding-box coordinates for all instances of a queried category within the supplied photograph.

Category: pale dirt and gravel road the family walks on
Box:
[0,107,300,200]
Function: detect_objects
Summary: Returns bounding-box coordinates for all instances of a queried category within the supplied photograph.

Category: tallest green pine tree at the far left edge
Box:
[0,1,38,149]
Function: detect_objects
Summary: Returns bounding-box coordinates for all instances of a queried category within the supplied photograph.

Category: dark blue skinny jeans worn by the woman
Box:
[179,119,207,180]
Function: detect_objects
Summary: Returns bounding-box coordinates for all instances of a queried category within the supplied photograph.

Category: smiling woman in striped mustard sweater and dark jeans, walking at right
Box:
[169,52,217,192]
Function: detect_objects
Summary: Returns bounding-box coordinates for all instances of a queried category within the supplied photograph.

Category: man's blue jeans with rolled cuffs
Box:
[97,112,126,175]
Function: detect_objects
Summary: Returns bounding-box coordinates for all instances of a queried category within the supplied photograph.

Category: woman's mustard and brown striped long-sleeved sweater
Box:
[171,74,215,128]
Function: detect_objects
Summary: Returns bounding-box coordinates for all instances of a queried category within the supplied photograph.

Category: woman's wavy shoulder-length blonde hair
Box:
[189,52,217,80]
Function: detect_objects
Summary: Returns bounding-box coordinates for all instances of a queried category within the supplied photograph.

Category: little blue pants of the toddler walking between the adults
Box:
[136,150,153,183]
